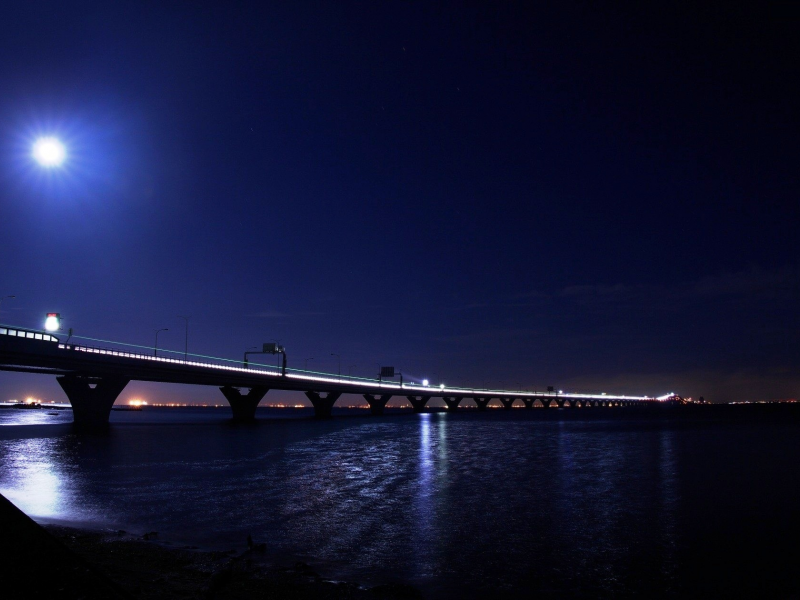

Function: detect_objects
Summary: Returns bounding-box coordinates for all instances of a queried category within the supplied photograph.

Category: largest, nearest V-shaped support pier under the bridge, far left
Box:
[56,375,130,428]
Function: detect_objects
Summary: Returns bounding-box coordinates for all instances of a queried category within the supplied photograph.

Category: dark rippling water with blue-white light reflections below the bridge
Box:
[0,406,800,598]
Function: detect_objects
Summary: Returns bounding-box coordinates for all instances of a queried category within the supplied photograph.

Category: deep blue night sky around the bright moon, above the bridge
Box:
[0,1,800,403]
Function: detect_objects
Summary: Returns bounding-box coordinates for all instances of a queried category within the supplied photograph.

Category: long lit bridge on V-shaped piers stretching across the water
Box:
[0,325,673,426]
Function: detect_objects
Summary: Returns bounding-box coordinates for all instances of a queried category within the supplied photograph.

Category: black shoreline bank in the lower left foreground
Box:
[0,496,421,600]
